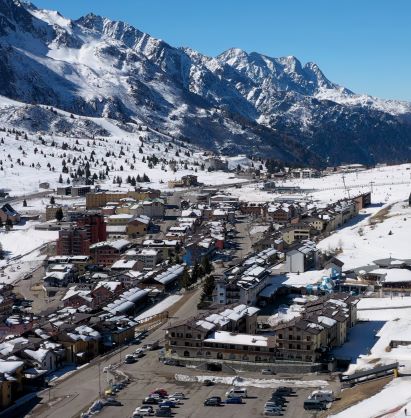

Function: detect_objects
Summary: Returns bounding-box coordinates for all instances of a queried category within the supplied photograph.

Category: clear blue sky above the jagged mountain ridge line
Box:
[33,0,411,101]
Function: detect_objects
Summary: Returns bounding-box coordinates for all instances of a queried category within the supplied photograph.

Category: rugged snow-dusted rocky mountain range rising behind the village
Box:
[0,0,411,164]
